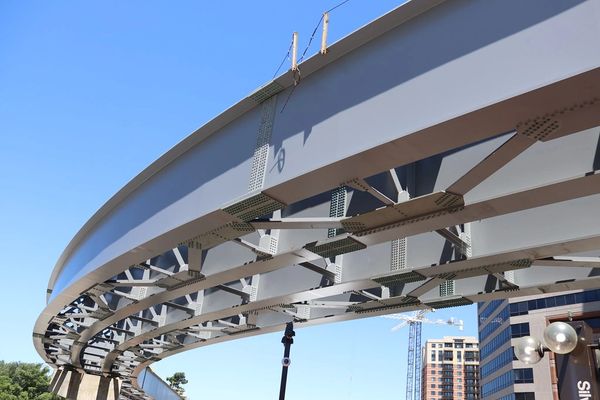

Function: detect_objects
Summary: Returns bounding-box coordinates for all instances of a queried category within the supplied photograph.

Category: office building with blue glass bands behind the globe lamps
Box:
[478,289,600,400]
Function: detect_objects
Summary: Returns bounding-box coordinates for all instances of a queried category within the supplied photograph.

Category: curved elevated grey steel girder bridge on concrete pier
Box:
[33,0,600,399]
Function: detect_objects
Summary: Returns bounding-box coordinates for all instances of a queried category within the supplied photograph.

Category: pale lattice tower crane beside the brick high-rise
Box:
[383,309,464,400]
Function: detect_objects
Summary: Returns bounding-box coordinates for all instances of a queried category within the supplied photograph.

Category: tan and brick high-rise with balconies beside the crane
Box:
[421,336,480,400]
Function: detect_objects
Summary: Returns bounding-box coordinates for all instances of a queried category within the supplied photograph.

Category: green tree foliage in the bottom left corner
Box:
[0,361,59,400]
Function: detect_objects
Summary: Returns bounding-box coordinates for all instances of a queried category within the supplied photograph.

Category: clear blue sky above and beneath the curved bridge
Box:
[0,0,477,400]
